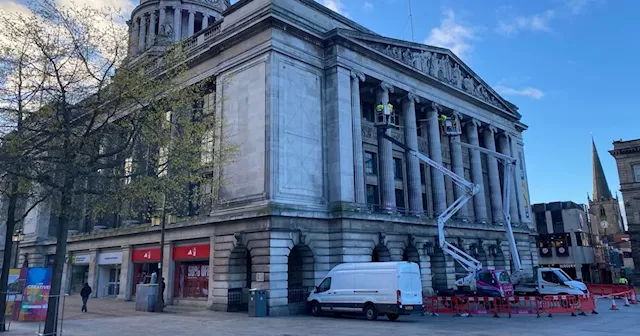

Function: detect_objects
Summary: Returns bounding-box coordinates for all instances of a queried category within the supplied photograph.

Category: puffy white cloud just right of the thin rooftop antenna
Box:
[425,9,477,58]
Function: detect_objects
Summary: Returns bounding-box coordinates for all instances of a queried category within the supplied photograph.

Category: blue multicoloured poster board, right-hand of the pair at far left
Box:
[19,267,51,321]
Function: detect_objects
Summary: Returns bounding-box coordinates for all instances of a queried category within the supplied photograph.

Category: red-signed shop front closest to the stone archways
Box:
[173,244,211,299]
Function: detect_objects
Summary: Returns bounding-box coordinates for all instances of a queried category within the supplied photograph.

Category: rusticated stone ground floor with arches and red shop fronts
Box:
[15,218,537,315]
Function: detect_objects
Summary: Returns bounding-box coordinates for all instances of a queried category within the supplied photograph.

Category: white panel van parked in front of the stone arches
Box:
[307,261,423,321]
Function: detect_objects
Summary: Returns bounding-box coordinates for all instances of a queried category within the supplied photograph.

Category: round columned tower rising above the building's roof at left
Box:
[128,0,231,56]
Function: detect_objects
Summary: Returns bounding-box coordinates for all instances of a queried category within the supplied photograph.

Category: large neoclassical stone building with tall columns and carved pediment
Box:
[2,0,538,315]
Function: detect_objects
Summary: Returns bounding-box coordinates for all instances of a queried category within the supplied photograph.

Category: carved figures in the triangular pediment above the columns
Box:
[367,42,509,111]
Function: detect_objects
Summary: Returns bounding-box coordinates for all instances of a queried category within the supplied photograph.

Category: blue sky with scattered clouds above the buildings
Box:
[0,0,640,207]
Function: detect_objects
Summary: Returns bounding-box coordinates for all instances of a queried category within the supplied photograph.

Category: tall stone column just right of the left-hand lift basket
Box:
[402,93,424,215]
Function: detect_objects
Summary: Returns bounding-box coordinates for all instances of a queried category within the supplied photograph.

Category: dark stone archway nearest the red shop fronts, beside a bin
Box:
[227,245,252,312]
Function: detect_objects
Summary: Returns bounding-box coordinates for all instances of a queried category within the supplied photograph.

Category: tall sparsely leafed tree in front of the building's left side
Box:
[0,0,235,335]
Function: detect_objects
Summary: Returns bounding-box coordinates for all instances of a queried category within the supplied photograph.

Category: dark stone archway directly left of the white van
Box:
[287,244,315,311]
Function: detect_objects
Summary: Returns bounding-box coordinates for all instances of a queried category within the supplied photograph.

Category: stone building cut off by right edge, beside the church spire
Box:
[609,139,640,285]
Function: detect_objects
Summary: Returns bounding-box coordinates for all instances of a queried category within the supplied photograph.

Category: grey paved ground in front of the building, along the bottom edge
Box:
[2,297,640,336]
